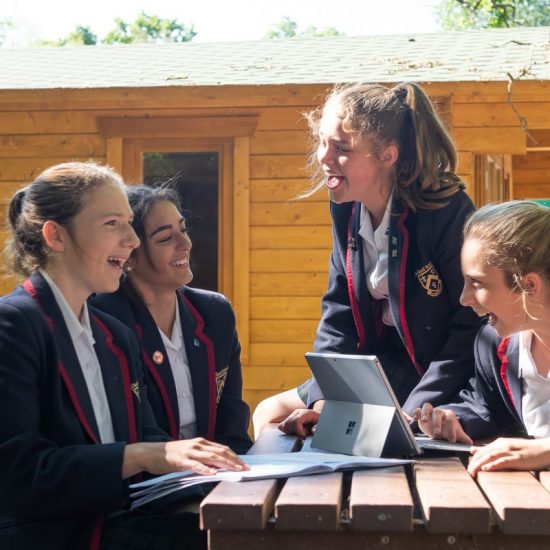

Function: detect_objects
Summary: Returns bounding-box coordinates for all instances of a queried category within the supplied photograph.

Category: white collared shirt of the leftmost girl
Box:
[40,270,115,443]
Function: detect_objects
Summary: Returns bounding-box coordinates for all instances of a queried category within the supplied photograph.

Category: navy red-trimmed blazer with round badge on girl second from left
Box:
[91,284,252,454]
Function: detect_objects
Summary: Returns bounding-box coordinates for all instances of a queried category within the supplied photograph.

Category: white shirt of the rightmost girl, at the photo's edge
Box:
[519,330,550,437]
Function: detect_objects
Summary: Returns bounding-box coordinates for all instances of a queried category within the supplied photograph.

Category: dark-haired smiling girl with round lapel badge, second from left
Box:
[92,186,252,453]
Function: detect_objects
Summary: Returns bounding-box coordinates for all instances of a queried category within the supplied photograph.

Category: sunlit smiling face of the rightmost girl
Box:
[460,238,531,337]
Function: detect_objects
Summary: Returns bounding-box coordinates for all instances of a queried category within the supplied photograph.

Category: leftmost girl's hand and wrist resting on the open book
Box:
[122,437,249,479]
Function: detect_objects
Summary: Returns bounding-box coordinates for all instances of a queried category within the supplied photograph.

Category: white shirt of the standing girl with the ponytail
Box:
[359,196,395,326]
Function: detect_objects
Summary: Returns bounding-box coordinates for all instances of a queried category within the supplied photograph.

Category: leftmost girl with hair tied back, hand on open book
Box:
[0,163,246,550]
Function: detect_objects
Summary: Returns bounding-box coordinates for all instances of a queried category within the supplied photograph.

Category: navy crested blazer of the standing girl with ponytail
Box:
[306,191,480,414]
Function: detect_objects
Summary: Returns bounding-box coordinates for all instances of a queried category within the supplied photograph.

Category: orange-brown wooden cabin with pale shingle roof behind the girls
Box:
[0,24,550,414]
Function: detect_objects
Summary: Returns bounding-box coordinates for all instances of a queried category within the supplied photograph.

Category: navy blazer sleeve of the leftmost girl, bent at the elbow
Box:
[0,302,126,518]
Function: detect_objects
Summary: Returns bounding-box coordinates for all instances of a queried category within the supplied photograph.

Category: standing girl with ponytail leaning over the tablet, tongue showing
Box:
[254,83,479,435]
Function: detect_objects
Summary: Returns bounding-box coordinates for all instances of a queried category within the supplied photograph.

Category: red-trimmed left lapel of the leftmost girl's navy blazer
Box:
[23,274,100,443]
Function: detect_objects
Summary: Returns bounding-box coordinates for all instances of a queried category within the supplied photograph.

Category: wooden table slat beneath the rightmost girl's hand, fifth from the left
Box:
[477,472,550,542]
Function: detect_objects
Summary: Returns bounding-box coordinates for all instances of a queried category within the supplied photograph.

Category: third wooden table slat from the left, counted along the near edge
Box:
[350,467,414,531]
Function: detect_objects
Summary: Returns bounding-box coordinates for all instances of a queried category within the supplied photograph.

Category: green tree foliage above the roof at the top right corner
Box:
[436,0,550,30]
